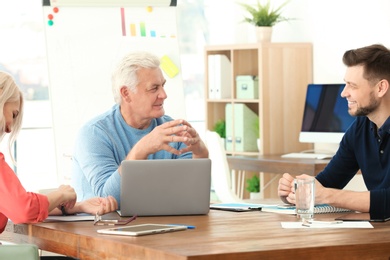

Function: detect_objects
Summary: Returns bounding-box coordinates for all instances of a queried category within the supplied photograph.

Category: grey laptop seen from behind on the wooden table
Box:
[118,158,211,216]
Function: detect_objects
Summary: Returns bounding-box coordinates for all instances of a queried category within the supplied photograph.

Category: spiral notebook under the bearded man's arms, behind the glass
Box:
[261,204,351,214]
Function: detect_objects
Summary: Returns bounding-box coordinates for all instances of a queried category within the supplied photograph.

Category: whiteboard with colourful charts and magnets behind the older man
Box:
[43,6,185,183]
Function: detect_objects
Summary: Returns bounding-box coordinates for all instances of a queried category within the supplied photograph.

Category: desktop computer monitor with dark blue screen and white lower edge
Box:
[299,84,355,147]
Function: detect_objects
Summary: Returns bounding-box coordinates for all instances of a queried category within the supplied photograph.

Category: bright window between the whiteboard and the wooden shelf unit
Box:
[177,0,247,134]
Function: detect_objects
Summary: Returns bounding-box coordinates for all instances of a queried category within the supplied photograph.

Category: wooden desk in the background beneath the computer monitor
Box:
[227,155,329,175]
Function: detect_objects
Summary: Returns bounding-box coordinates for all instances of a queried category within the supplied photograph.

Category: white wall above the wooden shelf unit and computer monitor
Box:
[208,0,390,83]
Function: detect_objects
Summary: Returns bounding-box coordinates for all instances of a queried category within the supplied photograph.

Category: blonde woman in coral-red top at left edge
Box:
[0,71,118,233]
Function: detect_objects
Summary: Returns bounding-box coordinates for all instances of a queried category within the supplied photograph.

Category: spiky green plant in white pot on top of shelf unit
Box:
[239,0,291,42]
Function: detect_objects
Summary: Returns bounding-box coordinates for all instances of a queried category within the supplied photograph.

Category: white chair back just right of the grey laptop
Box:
[205,130,241,203]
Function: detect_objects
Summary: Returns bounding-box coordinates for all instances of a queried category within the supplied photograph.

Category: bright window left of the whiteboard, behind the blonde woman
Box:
[0,0,57,191]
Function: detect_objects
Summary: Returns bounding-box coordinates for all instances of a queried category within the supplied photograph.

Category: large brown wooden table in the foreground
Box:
[3,210,390,260]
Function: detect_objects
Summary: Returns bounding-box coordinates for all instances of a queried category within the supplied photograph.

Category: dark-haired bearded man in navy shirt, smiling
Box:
[278,44,390,218]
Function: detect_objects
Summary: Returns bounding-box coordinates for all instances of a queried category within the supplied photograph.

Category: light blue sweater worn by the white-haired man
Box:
[72,105,192,205]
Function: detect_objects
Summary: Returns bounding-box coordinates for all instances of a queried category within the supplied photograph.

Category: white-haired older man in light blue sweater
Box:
[72,52,208,205]
